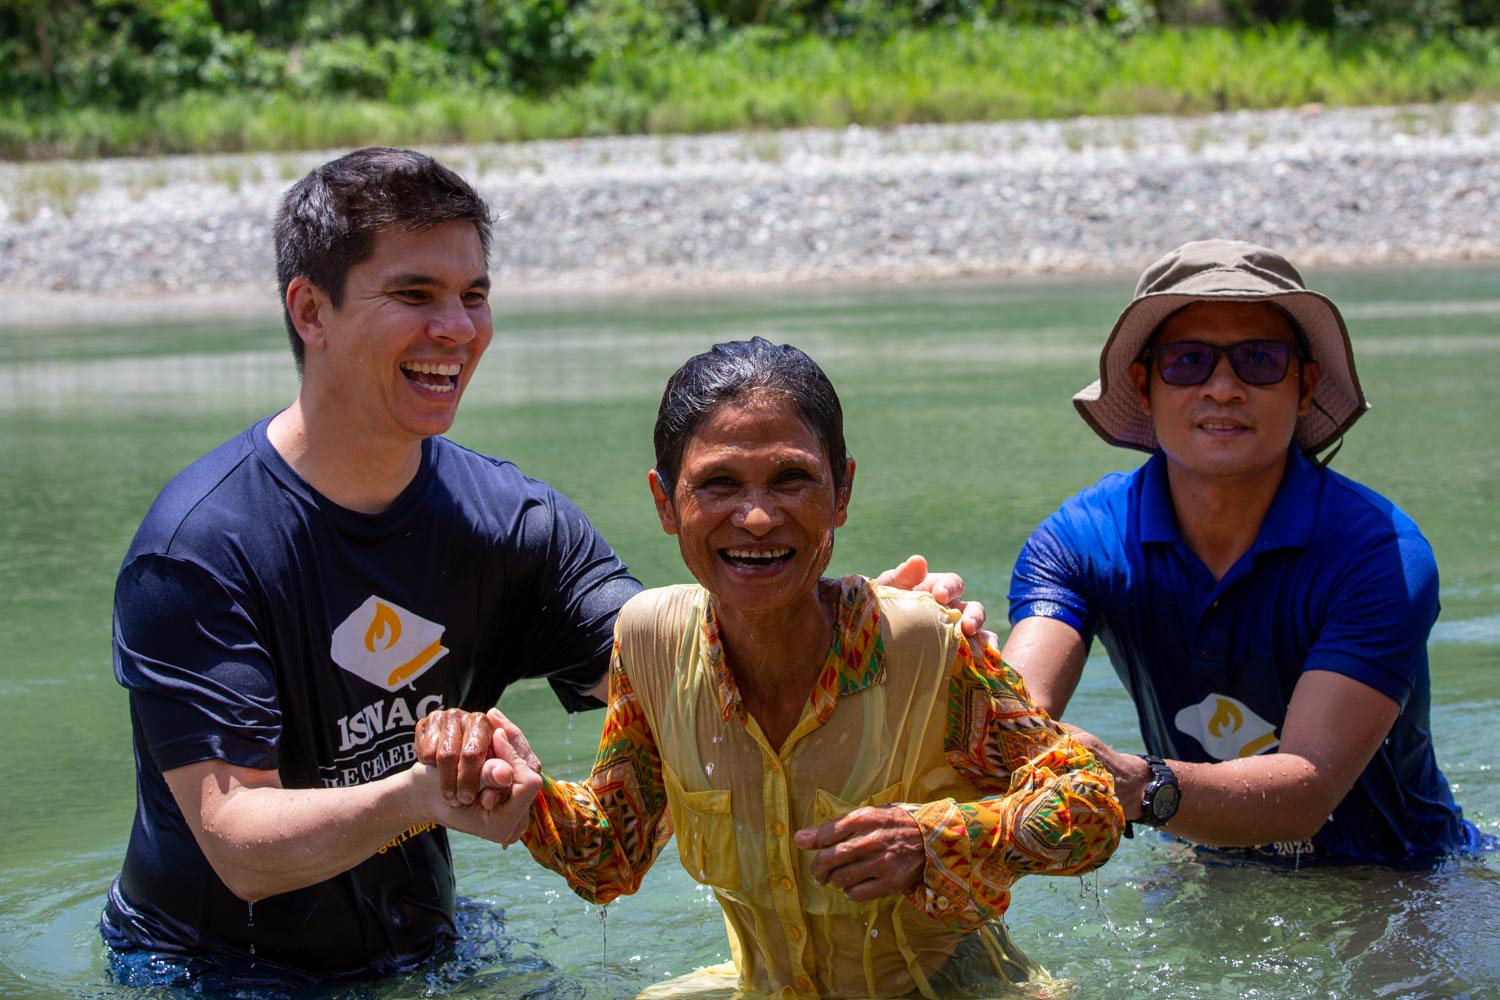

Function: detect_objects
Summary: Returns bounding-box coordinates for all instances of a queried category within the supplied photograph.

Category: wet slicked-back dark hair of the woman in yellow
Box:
[653,337,849,496]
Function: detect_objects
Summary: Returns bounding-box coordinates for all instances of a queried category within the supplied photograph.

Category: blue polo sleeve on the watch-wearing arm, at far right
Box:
[1304,529,1439,708]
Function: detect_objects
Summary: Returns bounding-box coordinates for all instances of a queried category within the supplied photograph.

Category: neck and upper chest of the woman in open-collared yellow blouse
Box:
[714,580,839,748]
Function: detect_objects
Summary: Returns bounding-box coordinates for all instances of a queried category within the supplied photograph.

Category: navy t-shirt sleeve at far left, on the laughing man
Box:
[114,555,282,772]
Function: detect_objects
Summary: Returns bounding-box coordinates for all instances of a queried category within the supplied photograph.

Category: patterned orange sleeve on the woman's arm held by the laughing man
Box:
[522,639,672,903]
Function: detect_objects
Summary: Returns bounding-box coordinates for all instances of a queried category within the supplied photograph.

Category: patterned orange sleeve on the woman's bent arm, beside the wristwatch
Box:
[903,642,1125,928]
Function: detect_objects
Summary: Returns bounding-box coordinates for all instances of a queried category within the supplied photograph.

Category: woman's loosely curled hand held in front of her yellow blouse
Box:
[795,805,927,903]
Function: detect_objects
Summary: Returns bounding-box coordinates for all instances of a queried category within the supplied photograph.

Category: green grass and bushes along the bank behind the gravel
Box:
[0,0,1500,159]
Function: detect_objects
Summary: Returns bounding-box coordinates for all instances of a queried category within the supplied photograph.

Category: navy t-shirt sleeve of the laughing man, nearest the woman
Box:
[524,487,641,712]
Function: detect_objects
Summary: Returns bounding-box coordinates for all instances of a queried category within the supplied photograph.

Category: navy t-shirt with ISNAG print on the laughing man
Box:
[102,420,641,978]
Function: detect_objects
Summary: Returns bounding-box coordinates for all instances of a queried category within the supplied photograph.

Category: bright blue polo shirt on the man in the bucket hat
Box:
[1010,450,1478,864]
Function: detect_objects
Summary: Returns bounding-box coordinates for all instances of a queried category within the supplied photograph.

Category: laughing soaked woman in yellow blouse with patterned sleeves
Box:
[432,337,1124,997]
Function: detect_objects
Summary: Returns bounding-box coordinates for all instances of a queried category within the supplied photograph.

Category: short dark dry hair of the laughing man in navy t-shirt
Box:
[276,147,492,373]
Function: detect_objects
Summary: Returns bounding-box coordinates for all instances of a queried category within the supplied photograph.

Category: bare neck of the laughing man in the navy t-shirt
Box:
[266,396,422,514]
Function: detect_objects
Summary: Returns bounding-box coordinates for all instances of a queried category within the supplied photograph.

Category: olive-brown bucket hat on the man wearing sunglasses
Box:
[1073,240,1370,457]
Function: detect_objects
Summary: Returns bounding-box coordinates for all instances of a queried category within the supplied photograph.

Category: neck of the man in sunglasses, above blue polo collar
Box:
[1167,457,1286,580]
